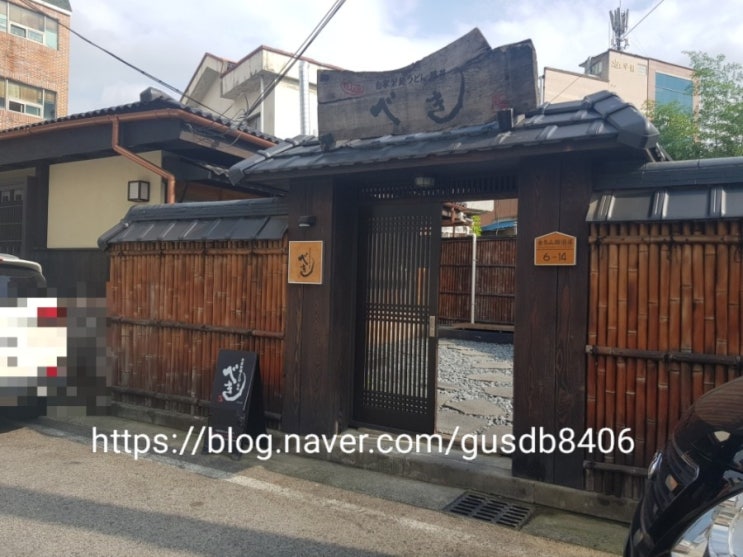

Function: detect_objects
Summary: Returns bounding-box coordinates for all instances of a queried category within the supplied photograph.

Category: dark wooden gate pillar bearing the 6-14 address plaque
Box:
[512,156,591,489]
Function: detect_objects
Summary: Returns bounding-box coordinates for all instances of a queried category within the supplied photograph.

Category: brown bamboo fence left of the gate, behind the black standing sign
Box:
[108,239,287,416]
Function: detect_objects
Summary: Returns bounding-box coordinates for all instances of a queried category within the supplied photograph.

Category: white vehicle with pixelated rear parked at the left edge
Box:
[0,254,67,417]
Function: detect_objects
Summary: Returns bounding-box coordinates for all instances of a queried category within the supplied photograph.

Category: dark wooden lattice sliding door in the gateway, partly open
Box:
[354,204,441,433]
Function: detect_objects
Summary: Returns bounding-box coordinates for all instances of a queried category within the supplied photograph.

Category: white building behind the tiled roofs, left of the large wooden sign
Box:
[181,46,340,138]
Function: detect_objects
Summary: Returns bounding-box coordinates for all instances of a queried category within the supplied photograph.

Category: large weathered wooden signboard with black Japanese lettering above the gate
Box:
[317,29,537,140]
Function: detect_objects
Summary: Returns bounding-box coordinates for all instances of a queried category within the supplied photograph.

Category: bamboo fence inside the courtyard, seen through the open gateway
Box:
[439,237,516,325]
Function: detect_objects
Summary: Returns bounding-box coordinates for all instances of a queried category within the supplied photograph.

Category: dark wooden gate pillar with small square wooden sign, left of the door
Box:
[282,179,356,434]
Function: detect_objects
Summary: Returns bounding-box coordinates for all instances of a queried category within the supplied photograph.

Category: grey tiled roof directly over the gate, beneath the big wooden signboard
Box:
[230,91,658,184]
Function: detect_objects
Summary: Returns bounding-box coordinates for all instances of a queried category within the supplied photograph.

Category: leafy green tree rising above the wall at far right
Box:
[648,52,743,160]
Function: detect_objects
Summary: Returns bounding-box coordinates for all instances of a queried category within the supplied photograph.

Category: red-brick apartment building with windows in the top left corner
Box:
[0,0,72,129]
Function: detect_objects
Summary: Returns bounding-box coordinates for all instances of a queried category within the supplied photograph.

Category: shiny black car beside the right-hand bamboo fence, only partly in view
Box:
[624,377,743,557]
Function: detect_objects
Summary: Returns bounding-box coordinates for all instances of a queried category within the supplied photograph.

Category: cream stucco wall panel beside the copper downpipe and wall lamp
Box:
[47,151,164,248]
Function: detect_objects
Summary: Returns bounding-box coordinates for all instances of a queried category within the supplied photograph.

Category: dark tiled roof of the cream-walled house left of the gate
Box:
[0,87,281,143]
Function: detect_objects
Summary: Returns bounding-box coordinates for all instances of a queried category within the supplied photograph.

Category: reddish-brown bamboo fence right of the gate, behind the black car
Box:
[586,221,743,498]
